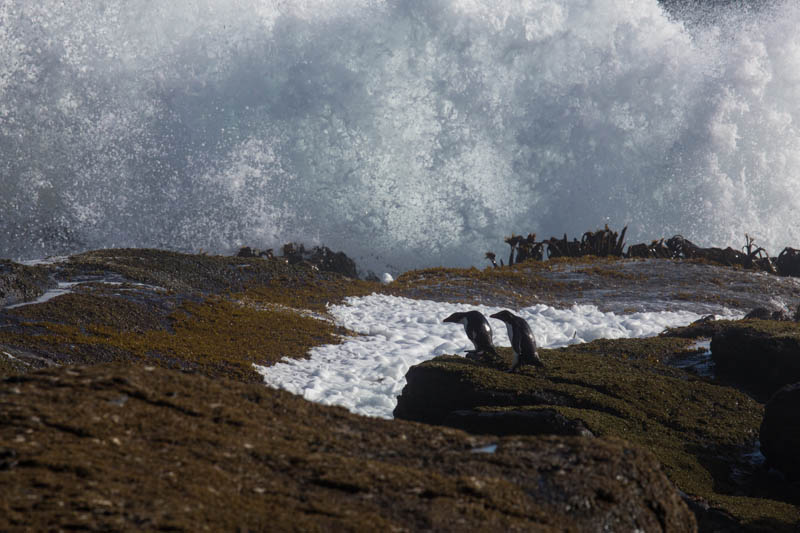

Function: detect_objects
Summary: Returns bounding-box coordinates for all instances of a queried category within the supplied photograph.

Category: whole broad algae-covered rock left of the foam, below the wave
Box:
[0,249,380,382]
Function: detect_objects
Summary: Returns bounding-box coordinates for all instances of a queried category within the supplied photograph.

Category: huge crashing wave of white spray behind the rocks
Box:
[0,0,800,275]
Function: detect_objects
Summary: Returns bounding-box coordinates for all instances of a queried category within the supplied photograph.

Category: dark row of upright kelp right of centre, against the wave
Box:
[494,225,800,277]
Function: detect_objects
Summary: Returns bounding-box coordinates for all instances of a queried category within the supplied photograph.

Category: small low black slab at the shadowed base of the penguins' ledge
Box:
[442,409,594,437]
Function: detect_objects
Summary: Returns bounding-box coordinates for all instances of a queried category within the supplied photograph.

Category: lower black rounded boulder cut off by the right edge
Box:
[760,383,800,479]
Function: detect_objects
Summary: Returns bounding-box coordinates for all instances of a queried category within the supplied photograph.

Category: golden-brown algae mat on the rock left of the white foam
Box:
[0,295,344,382]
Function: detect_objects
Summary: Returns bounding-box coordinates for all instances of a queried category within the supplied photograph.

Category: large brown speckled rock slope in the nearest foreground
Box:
[0,365,696,532]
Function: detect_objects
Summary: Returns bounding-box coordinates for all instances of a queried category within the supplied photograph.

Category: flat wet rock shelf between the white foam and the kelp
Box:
[392,257,800,314]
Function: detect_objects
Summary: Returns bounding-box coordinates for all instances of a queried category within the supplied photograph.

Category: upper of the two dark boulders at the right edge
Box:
[711,320,800,397]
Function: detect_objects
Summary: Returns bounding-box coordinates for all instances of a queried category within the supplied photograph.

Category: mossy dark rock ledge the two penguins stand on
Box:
[395,337,800,532]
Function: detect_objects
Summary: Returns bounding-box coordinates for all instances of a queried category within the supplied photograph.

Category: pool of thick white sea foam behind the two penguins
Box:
[256,294,733,418]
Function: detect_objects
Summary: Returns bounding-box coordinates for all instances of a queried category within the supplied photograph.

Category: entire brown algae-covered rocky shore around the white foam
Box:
[0,250,800,531]
